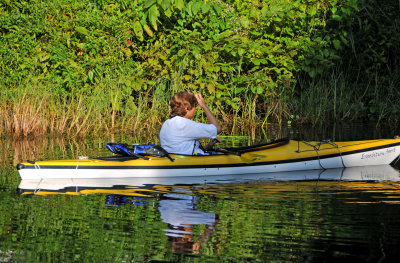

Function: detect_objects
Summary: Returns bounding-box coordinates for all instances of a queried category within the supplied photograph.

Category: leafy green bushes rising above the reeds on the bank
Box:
[0,0,399,136]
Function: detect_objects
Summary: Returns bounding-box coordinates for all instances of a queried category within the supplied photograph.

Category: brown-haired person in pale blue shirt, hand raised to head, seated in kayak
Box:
[160,92,222,155]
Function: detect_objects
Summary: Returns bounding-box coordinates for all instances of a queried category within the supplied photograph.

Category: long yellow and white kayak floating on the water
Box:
[17,138,400,180]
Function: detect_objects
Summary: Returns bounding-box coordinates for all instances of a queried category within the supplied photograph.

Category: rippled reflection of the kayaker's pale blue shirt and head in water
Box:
[158,194,216,254]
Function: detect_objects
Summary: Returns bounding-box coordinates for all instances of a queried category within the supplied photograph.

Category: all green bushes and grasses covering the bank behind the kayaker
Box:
[0,0,400,137]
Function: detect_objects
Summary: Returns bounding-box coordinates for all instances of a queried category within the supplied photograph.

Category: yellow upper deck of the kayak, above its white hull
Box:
[18,139,400,168]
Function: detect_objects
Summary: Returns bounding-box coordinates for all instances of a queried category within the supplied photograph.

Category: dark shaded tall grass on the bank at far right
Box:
[292,68,400,126]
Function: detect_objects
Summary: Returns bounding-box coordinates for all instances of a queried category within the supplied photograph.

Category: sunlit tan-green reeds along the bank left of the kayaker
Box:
[0,76,174,137]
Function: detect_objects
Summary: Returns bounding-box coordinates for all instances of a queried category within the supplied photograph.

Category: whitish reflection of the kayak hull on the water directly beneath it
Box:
[18,165,400,193]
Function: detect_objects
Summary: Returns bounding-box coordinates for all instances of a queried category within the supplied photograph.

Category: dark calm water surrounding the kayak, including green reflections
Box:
[0,125,400,262]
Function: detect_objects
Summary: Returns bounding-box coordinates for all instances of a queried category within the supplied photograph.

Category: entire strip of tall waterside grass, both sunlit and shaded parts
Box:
[0,69,400,138]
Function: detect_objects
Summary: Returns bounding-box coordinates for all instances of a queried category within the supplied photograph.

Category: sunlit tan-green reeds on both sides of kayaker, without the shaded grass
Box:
[0,74,272,138]
